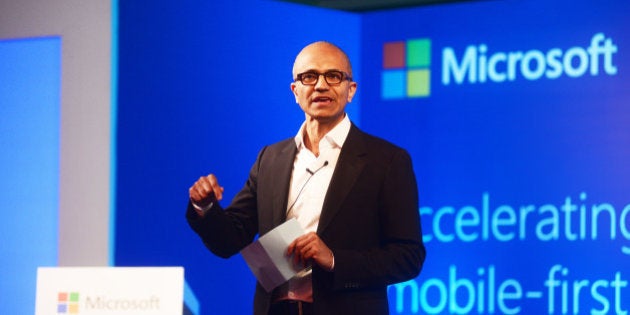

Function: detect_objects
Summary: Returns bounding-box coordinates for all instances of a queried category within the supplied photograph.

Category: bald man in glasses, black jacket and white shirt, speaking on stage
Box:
[187,42,425,315]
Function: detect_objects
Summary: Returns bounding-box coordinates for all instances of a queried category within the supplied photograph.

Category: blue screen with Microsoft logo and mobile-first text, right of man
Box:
[362,1,630,314]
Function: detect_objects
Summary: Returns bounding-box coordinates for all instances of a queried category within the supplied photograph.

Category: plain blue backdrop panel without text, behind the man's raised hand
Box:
[115,0,361,314]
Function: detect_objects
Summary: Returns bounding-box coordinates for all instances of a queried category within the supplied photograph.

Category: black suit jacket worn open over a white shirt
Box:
[187,125,426,315]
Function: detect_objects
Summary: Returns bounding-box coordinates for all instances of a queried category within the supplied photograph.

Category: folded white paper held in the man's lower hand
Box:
[241,218,305,292]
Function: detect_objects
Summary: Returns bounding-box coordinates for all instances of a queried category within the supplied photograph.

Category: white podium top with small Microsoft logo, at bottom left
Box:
[35,267,198,315]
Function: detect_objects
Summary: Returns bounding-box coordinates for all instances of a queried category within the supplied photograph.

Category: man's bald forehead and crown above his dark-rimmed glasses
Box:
[293,44,349,73]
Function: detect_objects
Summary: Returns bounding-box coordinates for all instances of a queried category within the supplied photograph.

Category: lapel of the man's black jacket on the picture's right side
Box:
[317,124,366,234]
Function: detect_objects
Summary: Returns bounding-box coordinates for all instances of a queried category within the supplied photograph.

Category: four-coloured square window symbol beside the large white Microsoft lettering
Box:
[381,38,431,99]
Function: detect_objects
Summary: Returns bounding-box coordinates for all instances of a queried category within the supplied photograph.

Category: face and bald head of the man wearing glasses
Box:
[291,43,357,123]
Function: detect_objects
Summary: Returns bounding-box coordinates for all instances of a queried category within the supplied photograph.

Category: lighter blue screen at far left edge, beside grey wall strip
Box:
[0,37,61,314]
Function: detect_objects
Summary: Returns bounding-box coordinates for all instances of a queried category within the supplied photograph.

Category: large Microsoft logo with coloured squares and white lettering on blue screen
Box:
[381,32,619,100]
